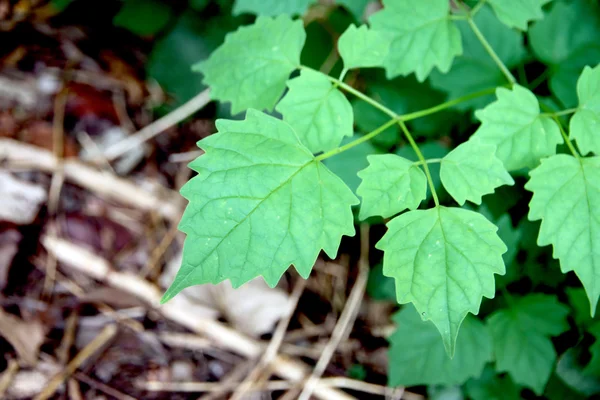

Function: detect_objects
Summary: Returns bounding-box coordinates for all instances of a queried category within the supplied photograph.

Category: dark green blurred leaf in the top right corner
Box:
[529,0,600,107]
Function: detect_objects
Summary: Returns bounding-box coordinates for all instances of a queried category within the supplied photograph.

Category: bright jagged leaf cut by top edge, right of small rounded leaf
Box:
[370,0,462,81]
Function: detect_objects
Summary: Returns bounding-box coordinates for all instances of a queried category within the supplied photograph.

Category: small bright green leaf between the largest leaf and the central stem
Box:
[356,154,427,220]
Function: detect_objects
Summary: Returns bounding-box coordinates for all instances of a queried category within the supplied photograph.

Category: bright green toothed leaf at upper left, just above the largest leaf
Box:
[193,15,306,114]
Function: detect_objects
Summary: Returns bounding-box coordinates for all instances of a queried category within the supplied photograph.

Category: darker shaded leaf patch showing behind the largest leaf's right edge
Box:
[324,135,381,193]
